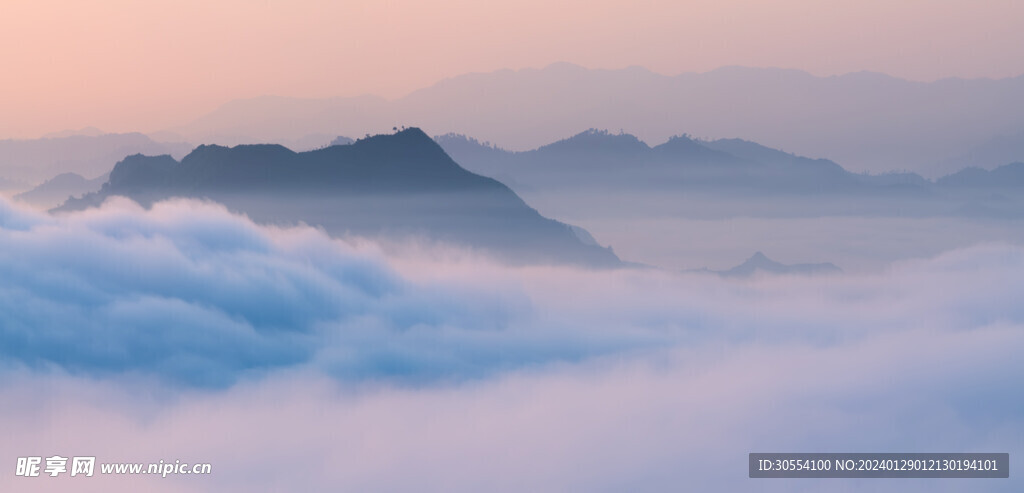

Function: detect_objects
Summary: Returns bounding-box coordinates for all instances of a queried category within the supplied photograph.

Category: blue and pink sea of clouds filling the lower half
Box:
[0,194,1024,492]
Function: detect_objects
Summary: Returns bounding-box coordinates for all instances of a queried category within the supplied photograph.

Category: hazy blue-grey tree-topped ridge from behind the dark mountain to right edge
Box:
[435,129,1024,218]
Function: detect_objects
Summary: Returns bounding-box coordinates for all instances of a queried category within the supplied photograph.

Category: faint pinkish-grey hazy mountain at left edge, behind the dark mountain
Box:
[0,133,191,184]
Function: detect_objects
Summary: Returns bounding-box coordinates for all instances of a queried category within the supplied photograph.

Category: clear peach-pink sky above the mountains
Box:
[0,0,1024,138]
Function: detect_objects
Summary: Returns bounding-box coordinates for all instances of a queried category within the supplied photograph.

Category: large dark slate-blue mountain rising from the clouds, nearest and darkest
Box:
[57,128,620,265]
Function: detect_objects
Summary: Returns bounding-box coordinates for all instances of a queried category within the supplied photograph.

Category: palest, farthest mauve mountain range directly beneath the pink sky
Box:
[163,64,1024,172]
